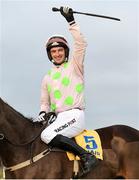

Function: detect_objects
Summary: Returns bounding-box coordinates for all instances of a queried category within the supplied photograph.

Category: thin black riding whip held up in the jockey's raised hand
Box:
[52,7,120,21]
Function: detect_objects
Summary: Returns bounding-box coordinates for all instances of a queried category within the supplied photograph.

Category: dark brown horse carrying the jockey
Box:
[0,98,139,179]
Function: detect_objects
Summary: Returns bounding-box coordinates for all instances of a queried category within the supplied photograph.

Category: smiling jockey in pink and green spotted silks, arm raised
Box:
[36,7,98,174]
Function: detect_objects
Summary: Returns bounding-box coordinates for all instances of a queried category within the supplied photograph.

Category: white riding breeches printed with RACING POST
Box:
[41,109,85,144]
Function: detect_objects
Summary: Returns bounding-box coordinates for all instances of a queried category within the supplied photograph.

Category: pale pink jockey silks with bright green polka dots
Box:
[41,24,87,112]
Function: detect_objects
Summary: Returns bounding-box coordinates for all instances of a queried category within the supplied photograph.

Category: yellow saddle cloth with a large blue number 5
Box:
[67,130,103,161]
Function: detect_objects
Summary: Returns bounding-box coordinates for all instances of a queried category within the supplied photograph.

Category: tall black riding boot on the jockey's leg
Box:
[49,134,98,174]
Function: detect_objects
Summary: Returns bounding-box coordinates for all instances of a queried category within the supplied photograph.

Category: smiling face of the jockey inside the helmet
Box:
[50,47,65,64]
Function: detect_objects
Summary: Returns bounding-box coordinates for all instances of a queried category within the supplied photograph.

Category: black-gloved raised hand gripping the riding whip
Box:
[60,7,75,24]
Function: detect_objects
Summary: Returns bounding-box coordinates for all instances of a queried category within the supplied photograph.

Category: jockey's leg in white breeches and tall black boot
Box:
[41,109,98,173]
